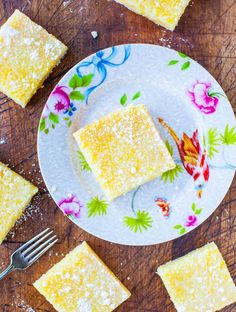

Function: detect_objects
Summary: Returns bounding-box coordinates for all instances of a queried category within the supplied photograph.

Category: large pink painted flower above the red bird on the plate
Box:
[188,82,222,114]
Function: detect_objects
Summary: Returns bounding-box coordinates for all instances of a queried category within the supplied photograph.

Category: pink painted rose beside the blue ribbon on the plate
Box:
[47,86,70,115]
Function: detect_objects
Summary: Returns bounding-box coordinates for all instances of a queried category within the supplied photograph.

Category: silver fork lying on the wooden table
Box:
[0,228,58,280]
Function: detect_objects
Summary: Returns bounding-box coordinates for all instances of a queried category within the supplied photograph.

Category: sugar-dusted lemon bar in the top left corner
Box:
[0,10,67,107]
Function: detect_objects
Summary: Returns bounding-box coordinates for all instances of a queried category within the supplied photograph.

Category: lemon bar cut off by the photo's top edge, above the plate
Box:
[115,0,190,30]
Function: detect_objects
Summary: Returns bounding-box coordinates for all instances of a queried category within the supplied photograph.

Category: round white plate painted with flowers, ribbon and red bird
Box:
[38,44,236,245]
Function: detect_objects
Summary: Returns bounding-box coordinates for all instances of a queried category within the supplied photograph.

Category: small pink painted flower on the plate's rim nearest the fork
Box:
[58,195,83,218]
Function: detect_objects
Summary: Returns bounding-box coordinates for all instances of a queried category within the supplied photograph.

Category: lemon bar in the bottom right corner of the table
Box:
[157,243,236,312]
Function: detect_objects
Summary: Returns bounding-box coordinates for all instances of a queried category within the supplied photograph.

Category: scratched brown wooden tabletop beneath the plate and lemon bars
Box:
[0,0,236,312]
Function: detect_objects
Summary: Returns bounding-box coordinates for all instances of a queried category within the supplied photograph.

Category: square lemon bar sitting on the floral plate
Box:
[74,104,175,200]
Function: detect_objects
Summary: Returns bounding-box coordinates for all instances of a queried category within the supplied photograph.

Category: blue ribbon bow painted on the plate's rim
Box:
[76,45,131,104]
